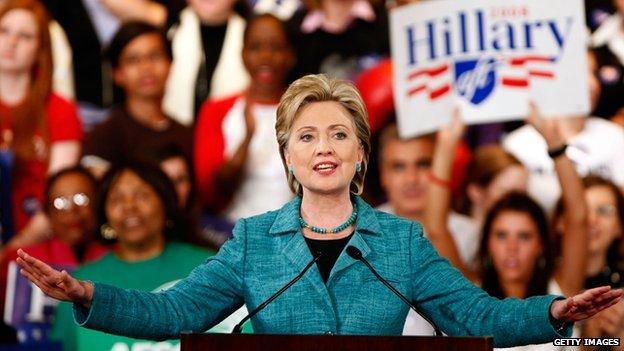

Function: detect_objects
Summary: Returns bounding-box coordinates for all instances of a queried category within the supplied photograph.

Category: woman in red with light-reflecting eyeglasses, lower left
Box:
[0,167,108,339]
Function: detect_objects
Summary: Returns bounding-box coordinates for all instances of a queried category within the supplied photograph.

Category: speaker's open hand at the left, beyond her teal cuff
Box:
[17,249,93,308]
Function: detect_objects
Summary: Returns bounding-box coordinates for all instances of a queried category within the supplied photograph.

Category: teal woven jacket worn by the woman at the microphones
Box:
[74,197,571,347]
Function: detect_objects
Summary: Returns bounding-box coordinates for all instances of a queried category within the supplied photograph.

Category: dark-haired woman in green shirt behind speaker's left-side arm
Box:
[50,161,214,351]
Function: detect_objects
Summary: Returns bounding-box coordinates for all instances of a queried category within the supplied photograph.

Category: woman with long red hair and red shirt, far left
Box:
[0,0,82,250]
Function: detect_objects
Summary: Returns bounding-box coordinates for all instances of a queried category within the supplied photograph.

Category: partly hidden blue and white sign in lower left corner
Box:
[4,261,74,343]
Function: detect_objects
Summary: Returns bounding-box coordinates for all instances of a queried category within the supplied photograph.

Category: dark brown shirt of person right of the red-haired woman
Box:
[83,107,193,163]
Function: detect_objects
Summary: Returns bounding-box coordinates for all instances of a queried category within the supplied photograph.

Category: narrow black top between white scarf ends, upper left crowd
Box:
[194,22,227,116]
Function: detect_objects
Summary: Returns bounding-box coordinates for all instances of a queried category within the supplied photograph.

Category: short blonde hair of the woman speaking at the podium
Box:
[275,74,371,195]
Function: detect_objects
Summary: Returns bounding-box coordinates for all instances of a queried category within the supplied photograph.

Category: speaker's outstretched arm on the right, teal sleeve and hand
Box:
[409,224,622,347]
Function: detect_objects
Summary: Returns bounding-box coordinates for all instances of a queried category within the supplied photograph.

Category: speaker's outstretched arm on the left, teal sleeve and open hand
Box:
[18,220,245,340]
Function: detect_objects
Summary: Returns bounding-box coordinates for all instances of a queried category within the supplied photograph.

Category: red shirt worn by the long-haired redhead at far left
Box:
[0,93,82,232]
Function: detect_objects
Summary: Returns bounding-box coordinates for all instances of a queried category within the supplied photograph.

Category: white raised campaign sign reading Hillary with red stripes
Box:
[390,0,590,137]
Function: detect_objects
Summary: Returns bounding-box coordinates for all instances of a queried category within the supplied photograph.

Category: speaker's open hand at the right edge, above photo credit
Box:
[550,286,624,322]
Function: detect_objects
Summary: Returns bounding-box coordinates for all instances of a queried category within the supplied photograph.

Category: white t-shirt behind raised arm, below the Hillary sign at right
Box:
[503,117,624,213]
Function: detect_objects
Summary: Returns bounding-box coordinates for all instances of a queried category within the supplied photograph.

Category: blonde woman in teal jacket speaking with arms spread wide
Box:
[18,75,622,347]
